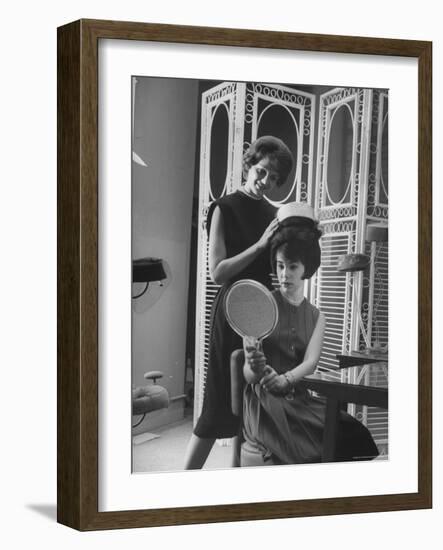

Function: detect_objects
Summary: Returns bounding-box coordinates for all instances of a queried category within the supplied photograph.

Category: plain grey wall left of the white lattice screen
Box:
[132,78,198,431]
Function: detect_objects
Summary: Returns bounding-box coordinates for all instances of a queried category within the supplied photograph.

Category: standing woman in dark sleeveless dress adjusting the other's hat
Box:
[185,136,294,469]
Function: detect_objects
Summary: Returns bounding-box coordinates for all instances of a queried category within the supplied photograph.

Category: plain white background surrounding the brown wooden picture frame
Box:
[0,0,443,550]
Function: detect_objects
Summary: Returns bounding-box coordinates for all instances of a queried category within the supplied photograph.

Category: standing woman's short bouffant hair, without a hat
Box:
[243,136,294,186]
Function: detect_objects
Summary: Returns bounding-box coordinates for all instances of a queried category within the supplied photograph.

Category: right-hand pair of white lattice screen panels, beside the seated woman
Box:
[314,88,388,452]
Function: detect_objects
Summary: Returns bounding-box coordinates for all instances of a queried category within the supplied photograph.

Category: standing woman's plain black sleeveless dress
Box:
[194,191,276,438]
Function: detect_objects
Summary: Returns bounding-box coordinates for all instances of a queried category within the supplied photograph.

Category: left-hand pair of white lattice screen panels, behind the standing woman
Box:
[194,82,315,419]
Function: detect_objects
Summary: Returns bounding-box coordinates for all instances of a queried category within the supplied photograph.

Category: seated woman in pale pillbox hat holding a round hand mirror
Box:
[241,203,378,466]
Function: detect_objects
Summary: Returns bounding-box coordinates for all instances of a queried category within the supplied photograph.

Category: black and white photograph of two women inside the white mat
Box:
[128,75,389,473]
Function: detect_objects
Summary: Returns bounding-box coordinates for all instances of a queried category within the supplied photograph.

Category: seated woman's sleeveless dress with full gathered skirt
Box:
[243,291,378,464]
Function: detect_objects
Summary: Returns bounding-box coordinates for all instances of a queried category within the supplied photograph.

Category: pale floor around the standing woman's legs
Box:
[132,415,232,472]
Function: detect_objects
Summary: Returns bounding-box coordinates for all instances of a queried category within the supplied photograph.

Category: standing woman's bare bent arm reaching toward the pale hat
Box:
[209,206,278,285]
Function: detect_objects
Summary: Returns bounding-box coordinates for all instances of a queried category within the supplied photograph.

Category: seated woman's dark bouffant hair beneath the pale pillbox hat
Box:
[271,217,322,279]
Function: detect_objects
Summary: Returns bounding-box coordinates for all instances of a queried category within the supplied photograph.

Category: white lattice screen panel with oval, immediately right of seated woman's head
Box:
[313,88,371,381]
